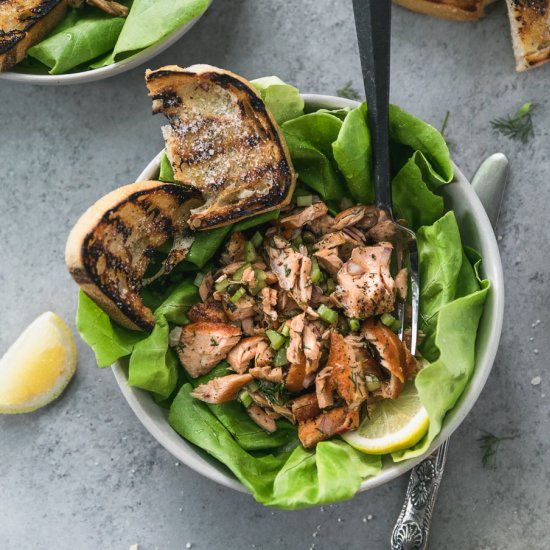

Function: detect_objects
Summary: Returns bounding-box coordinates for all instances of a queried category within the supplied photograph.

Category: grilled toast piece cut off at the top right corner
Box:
[506,0,550,71]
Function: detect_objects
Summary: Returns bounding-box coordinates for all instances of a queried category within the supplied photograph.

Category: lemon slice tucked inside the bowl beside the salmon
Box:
[342,382,430,455]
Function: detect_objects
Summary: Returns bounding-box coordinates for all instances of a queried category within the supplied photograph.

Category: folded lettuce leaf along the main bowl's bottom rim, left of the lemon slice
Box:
[168,384,381,510]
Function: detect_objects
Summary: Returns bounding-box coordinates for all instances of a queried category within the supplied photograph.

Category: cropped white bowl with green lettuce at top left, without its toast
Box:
[0,0,213,85]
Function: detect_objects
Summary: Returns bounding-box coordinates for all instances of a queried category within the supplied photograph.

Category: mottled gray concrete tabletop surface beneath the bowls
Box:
[0,0,550,550]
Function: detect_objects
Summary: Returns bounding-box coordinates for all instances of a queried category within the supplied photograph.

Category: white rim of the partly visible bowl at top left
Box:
[0,0,213,86]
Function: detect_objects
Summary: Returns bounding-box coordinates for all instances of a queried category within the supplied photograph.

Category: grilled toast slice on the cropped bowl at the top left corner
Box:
[0,0,67,71]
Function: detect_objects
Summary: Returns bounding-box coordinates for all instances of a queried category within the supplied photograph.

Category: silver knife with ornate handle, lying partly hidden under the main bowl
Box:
[391,153,508,550]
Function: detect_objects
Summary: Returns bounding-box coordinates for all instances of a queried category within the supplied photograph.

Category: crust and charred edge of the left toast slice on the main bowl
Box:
[65,180,201,331]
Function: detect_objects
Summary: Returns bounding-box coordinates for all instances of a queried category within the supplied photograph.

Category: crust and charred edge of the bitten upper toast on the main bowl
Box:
[145,65,296,230]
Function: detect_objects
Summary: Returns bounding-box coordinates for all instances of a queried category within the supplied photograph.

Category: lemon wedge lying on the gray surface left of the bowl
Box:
[0,311,76,414]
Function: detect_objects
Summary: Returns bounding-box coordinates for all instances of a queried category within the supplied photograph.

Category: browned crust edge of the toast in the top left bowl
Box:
[0,0,67,71]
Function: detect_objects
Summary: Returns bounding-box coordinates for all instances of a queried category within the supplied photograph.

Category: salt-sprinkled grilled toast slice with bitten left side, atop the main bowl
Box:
[145,65,296,229]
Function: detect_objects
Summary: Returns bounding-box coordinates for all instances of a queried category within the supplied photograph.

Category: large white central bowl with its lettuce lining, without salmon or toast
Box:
[77,92,504,509]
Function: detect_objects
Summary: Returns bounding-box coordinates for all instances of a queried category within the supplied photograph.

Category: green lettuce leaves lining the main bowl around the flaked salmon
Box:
[77,77,489,509]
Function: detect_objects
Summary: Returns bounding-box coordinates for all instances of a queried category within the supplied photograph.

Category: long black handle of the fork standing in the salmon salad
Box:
[353,0,392,214]
